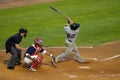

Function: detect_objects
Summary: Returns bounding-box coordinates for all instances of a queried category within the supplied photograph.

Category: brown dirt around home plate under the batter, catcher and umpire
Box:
[0,41,120,80]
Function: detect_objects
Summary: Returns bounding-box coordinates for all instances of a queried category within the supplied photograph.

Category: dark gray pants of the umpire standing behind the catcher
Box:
[8,46,21,67]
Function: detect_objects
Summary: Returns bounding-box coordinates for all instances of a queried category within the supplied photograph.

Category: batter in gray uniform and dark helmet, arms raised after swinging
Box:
[56,17,85,62]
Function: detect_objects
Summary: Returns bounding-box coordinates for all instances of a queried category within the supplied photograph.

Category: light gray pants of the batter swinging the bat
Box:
[57,39,84,62]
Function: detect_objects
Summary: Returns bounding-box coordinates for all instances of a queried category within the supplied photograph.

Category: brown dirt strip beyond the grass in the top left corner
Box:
[0,0,58,9]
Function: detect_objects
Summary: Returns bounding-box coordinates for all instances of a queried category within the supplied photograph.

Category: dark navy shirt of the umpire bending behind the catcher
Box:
[5,33,22,53]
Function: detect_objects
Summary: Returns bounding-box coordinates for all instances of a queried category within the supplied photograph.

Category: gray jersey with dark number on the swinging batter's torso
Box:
[64,26,80,42]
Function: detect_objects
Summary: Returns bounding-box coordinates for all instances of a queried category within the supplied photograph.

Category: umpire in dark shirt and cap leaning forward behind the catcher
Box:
[5,28,28,70]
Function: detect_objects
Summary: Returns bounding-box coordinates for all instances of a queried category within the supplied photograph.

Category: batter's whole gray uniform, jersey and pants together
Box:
[57,26,84,62]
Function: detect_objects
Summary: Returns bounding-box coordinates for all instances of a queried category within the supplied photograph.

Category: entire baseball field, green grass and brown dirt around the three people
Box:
[0,0,120,80]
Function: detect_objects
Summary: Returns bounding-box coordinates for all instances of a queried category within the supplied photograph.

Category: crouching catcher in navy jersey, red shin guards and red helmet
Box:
[23,38,55,71]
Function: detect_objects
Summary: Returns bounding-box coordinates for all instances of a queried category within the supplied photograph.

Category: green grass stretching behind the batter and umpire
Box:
[0,0,120,49]
